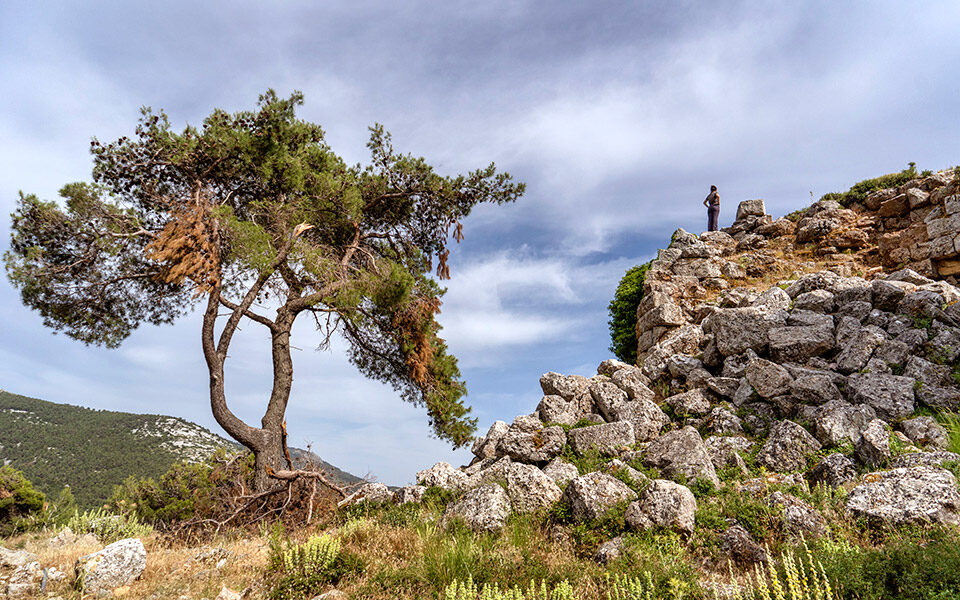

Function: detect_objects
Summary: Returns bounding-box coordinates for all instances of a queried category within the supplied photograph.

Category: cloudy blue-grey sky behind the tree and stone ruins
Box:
[0,0,960,485]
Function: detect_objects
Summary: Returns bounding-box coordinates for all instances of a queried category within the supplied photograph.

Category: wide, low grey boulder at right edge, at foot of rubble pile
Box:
[847,467,960,525]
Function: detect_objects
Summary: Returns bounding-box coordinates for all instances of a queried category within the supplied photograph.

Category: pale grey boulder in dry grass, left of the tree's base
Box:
[74,538,147,595]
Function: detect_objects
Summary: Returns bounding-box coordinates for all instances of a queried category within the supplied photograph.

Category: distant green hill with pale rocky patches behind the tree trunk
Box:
[0,390,360,508]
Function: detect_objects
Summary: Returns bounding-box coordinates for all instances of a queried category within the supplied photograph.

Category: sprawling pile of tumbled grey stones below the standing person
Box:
[351,178,960,562]
